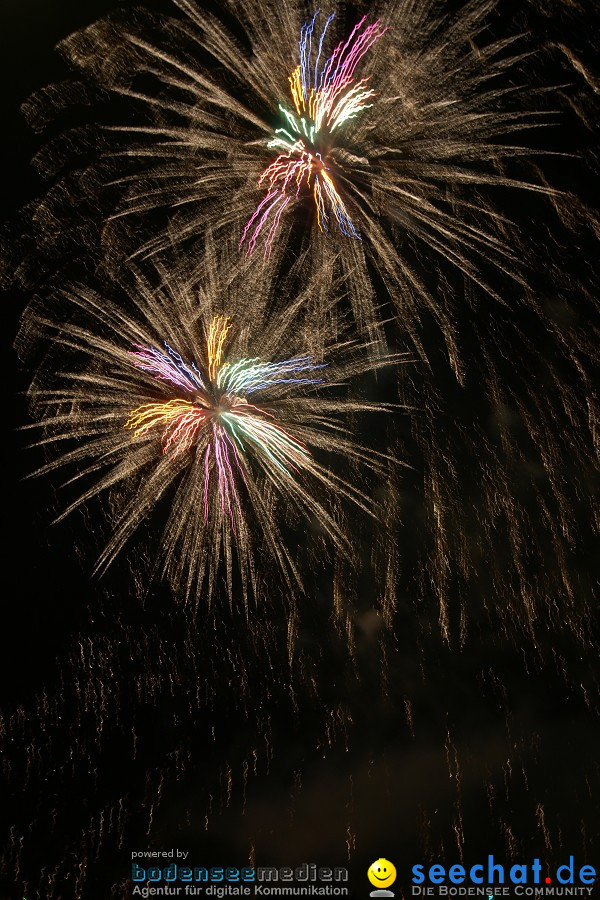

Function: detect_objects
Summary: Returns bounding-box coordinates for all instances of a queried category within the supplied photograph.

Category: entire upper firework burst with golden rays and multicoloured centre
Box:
[14,0,559,344]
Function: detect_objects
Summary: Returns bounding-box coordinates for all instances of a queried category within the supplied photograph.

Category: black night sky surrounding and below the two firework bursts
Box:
[0,0,600,900]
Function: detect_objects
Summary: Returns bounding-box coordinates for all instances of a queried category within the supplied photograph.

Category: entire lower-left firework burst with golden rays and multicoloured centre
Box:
[20,253,398,600]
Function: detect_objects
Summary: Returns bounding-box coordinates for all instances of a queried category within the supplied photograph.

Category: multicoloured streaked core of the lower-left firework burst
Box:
[125,316,324,531]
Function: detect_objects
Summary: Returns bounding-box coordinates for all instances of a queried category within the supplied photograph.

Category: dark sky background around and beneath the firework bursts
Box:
[0,0,600,900]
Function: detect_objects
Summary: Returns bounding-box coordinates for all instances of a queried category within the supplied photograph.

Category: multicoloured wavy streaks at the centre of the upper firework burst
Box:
[240,13,386,252]
